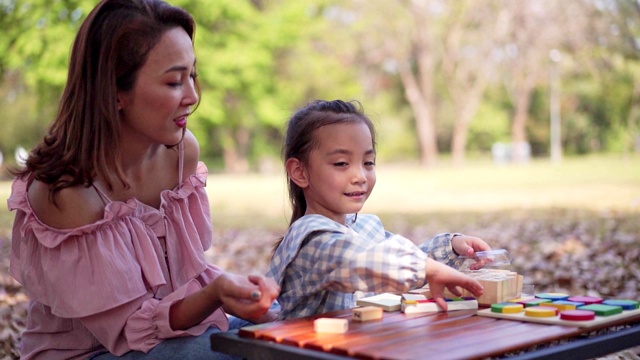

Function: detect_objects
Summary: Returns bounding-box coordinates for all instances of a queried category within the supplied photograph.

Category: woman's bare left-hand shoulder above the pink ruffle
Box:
[27,180,104,229]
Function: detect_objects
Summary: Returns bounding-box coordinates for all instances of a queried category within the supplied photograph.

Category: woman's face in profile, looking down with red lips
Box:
[118,27,198,145]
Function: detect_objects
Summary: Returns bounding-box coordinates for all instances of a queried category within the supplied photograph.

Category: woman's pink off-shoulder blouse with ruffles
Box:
[8,147,228,359]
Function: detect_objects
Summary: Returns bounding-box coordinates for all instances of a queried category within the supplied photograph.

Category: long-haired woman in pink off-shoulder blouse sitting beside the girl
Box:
[8,0,278,360]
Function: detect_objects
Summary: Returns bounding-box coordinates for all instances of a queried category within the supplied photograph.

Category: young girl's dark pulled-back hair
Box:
[274,100,376,255]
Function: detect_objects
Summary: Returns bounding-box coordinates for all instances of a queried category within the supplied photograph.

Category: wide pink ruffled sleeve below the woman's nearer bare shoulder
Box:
[8,179,165,317]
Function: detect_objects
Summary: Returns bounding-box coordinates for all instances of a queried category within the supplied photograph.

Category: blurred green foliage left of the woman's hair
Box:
[0,0,95,165]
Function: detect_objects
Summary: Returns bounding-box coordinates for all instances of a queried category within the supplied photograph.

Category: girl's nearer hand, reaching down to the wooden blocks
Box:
[427,258,484,311]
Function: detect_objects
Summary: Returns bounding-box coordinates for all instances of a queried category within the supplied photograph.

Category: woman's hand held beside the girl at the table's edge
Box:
[212,273,280,322]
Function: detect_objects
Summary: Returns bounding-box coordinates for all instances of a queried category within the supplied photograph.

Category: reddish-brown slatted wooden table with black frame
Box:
[211,310,640,360]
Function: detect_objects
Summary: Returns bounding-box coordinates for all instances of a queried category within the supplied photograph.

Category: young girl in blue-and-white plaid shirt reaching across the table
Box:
[267,100,490,319]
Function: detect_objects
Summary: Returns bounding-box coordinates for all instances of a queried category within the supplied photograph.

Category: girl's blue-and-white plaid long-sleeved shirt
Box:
[267,214,464,319]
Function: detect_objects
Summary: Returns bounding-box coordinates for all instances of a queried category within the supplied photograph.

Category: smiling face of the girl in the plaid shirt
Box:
[303,122,376,224]
